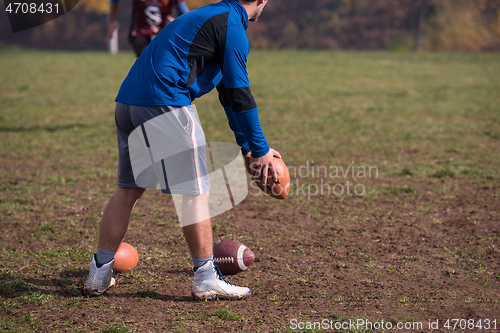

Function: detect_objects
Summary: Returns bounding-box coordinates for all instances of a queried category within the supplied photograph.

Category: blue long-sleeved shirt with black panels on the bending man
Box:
[116,0,269,157]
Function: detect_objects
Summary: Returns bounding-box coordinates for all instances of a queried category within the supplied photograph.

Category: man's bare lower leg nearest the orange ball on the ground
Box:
[98,187,144,251]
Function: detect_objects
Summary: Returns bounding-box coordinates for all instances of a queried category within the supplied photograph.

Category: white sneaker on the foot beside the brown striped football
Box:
[192,260,250,300]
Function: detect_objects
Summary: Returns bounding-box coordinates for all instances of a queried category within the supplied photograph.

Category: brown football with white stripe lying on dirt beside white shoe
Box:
[214,240,255,275]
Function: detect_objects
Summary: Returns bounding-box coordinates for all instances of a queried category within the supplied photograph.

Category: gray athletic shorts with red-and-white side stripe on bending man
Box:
[115,102,210,195]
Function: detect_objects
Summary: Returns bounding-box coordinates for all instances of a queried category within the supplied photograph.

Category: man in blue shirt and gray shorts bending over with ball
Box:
[84,0,279,299]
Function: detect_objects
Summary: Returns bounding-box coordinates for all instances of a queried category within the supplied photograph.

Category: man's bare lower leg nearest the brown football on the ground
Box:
[181,191,213,258]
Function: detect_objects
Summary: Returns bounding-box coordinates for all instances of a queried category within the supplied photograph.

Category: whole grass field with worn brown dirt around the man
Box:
[0,49,500,332]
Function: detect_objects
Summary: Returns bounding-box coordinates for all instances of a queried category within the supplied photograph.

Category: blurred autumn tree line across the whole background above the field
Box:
[0,0,500,52]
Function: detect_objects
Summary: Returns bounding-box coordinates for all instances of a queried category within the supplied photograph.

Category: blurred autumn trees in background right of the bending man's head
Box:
[249,0,500,51]
